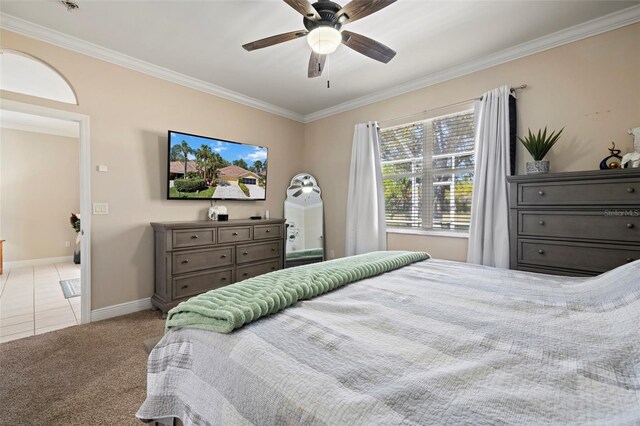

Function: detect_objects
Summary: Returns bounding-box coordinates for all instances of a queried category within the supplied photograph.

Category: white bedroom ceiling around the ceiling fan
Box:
[0,0,640,117]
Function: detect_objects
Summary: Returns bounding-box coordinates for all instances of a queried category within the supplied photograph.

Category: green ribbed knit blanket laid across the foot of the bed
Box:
[165,251,431,333]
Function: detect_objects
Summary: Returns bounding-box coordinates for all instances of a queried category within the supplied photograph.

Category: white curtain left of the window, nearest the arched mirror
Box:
[345,122,387,256]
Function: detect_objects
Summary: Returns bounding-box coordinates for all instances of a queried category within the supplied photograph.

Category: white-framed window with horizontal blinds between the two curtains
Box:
[380,111,474,233]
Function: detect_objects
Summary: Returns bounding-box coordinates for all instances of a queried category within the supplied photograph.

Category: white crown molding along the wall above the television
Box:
[0,12,304,122]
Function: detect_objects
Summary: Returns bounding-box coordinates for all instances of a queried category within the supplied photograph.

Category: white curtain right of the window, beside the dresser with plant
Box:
[467,86,511,269]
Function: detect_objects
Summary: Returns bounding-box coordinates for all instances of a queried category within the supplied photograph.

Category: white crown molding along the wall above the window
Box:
[304,5,640,123]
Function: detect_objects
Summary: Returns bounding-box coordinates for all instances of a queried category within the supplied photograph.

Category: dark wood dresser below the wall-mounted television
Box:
[151,219,284,317]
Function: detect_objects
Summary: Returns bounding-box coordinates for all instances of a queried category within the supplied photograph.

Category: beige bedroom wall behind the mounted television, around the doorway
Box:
[0,31,304,309]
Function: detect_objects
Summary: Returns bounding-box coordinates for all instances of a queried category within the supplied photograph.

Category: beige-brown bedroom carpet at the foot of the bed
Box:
[0,311,164,425]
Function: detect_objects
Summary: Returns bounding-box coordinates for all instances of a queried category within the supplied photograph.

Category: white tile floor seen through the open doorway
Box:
[0,263,80,343]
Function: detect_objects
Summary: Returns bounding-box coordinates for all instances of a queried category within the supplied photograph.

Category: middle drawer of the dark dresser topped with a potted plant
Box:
[518,209,640,243]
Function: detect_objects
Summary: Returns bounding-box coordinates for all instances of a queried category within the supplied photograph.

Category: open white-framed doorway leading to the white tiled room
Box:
[0,99,91,343]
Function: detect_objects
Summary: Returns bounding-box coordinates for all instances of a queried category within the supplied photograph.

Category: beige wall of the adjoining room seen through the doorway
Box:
[0,129,80,262]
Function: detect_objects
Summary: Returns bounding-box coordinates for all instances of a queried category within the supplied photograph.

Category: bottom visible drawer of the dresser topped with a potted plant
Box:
[518,239,640,272]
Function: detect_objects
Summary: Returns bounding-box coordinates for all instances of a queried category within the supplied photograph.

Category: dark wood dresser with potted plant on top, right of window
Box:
[507,169,640,276]
